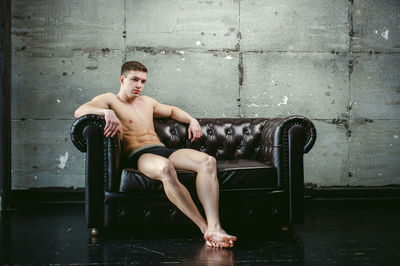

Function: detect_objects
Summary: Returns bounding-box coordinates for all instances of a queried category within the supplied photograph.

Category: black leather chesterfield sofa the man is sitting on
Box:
[71,115,316,233]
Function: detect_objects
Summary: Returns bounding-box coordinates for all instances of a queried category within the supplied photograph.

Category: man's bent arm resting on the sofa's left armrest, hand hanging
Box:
[74,93,120,137]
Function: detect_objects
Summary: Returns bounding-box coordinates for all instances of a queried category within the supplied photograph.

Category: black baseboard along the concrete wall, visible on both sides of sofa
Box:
[5,185,400,205]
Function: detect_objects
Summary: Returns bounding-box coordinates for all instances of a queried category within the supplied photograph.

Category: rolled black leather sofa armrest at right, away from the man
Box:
[261,116,317,224]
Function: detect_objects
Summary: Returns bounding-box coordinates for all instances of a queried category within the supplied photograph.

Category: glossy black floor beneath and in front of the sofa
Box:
[0,200,400,265]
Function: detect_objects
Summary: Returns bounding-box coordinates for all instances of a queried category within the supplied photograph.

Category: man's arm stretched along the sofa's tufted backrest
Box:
[153,96,202,140]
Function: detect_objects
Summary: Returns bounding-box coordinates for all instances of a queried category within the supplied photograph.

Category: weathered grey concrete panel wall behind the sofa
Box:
[12,0,400,189]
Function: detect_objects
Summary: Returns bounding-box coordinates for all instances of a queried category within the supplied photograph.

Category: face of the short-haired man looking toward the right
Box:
[120,70,147,98]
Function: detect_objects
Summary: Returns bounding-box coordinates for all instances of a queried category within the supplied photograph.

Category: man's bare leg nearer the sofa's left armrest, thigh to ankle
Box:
[138,154,208,234]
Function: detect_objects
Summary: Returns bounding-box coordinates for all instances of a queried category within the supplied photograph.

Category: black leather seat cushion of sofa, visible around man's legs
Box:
[120,159,278,193]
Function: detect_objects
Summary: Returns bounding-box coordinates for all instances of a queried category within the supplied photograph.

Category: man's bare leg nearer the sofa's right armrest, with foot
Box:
[169,149,237,247]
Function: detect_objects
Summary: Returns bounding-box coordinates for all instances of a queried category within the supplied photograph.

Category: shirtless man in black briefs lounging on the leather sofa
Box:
[75,61,237,247]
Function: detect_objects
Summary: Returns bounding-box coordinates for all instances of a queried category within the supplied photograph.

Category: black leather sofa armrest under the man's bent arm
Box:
[71,114,121,227]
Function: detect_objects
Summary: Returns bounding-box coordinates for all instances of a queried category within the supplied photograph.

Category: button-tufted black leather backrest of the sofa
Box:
[154,118,268,160]
